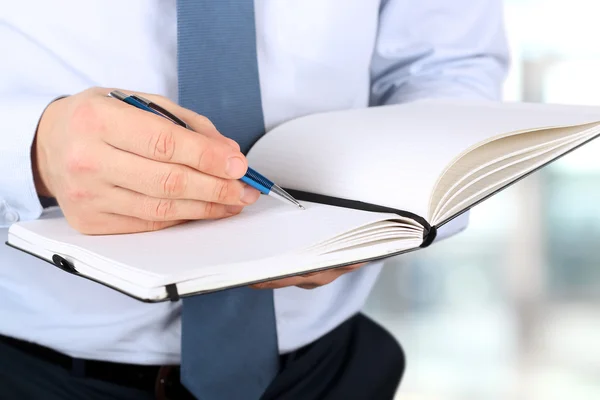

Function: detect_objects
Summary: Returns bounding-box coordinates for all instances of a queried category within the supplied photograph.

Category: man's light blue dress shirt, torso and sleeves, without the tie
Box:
[0,0,507,364]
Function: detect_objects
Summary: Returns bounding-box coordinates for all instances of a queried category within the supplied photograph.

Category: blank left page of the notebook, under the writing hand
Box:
[11,196,396,282]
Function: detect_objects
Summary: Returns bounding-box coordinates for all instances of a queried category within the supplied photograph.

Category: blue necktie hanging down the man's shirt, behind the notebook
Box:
[177,0,279,400]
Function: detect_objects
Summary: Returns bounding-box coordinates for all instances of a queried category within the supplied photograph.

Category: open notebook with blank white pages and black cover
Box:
[8,101,600,301]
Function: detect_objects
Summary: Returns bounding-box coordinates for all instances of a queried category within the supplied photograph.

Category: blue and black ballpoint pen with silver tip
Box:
[108,90,305,210]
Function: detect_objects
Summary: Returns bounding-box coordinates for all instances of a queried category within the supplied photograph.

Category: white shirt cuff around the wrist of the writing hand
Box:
[0,95,60,227]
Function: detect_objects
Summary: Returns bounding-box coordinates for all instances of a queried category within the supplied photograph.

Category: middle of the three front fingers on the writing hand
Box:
[101,148,260,205]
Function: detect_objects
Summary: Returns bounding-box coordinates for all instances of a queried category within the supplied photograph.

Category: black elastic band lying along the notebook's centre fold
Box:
[284,189,437,247]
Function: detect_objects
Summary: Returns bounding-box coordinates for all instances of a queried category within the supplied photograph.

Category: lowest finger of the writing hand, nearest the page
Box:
[99,187,243,222]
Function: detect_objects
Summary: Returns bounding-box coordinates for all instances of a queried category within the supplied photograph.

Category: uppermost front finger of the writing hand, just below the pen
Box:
[102,98,248,179]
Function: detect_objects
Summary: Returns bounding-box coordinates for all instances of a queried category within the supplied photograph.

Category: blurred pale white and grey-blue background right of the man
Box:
[366,0,600,400]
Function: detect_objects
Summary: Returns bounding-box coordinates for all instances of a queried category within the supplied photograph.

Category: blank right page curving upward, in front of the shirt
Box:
[248,100,600,217]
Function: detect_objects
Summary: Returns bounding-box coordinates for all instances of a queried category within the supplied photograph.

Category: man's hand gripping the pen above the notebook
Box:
[32,88,298,234]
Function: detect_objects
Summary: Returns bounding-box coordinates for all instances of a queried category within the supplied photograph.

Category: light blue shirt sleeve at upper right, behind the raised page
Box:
[370,0,508,105]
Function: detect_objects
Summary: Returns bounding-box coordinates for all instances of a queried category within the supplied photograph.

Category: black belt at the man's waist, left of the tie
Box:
[0,335,193,399]
